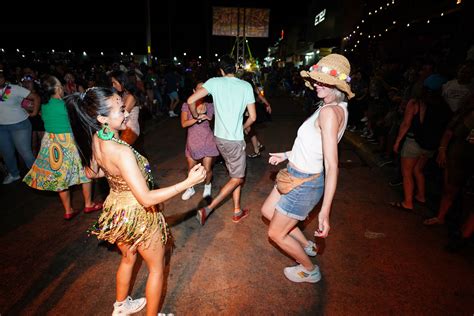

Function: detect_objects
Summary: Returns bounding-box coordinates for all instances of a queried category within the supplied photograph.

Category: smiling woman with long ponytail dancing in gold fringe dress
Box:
[65,88,206,315]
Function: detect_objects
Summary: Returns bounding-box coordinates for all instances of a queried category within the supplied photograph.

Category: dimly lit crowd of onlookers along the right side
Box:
[340,55,474,250]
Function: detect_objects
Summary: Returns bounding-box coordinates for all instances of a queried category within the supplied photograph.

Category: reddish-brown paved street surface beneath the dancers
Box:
[0,98,474,315]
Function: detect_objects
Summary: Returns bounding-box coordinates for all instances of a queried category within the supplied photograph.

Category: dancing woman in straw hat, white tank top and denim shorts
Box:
[262,54,354,283]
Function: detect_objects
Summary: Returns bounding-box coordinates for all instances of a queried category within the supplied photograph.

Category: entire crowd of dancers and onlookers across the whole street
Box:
[0,43,474,315]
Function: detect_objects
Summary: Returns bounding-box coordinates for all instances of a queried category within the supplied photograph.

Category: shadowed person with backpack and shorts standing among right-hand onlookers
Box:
[390,74,450,211]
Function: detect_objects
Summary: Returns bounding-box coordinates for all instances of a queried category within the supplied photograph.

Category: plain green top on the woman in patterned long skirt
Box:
[41,98,72,134]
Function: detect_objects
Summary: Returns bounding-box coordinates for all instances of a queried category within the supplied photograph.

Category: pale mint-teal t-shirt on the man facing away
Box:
[203,77,255,140]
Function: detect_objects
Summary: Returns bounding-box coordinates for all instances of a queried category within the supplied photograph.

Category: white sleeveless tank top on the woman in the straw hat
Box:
[288,102,348,173]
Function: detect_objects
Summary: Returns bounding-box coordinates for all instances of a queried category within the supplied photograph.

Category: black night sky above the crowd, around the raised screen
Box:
[0,0,308,58]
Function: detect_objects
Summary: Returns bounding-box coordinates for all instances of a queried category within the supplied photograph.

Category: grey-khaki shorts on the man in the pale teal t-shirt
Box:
[216,137,247,178]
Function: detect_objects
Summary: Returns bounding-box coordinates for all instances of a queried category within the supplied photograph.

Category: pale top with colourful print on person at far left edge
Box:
[0,83,30,125]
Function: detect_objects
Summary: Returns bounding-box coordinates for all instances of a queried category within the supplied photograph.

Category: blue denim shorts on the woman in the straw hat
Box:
[276,165,324,221]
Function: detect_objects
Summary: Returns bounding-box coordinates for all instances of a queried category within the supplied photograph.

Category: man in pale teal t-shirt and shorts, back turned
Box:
[188,56,257,225]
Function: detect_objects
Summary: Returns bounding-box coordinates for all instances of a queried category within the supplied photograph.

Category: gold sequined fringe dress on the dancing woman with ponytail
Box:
[90,138,170,248]
